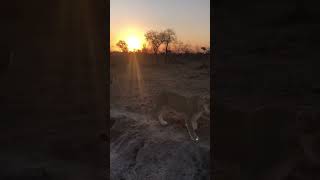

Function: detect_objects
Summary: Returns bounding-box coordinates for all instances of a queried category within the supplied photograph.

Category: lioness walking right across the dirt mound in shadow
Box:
[152,91,210,141]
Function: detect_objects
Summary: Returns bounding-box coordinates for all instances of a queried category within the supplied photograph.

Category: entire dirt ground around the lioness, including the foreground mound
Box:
[110,55,210,179]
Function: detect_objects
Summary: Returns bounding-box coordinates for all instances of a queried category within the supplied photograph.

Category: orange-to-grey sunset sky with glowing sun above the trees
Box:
[110,0,210,50]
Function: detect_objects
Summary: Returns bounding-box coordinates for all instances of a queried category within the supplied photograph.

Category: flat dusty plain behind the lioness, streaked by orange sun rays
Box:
[110,55,210,112]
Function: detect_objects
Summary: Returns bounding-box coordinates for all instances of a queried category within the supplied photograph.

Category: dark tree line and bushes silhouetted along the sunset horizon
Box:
[111,28,210,64]
